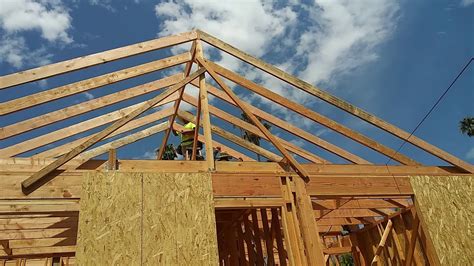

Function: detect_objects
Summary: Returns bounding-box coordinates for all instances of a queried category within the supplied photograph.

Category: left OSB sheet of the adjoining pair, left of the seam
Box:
[77,172,142,265]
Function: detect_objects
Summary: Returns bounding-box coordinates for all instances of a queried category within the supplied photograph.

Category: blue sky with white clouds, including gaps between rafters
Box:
[0,0,474,164]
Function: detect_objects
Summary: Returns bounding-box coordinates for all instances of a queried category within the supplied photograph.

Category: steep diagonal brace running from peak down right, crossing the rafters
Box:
[196,57,309,182]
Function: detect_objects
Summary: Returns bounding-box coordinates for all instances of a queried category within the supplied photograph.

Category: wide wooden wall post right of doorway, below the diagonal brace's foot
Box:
[293,178,324,265]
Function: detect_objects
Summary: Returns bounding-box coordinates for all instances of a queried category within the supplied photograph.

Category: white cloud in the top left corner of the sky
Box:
[0,0,73,68]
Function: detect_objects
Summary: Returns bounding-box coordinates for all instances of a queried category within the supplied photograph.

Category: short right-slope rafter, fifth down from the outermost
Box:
[178,111,282,162]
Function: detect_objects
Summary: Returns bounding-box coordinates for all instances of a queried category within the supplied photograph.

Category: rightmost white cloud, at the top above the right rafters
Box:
[297,0,398,84]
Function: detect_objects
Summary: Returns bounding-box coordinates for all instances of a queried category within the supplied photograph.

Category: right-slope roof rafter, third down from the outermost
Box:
[191,81,371,164]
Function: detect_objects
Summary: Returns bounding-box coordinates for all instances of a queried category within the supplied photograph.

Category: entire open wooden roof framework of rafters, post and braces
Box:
[0,30,474,195]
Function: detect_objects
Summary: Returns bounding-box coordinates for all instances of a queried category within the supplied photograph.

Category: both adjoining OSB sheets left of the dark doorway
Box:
[77,172,218,265]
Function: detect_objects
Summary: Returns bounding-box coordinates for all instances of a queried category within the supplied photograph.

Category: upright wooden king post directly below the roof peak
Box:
[196,41,216,171]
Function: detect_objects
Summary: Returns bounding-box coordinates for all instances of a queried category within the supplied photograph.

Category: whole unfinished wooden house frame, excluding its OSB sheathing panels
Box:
[0,30,474,265]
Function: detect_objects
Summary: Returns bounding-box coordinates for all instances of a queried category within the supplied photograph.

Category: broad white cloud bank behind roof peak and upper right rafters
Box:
[155,0,399,129]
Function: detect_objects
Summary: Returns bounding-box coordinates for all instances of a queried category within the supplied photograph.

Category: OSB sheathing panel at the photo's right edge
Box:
[410,176,474,265]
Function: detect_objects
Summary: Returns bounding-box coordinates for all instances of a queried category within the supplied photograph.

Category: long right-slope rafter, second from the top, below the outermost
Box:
[206,61,419,165]
